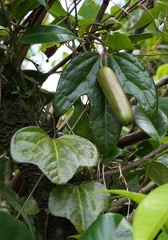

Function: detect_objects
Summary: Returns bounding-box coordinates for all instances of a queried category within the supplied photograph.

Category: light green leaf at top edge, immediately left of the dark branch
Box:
[78,0,100,20]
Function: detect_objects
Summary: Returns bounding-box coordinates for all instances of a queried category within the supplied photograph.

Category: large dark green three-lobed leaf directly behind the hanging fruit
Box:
[54,52,157,157]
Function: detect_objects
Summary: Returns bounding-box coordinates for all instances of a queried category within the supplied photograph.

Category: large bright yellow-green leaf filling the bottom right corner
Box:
[133,184,168,240]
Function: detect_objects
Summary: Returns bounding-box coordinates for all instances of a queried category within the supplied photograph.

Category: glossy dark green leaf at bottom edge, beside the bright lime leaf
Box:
[79,213,133,240]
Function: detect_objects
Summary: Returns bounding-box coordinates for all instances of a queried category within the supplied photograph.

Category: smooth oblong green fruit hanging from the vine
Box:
[97,67,134,126]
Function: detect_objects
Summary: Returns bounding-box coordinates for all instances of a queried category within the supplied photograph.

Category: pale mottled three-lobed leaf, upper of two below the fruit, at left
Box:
[10,127,98,184]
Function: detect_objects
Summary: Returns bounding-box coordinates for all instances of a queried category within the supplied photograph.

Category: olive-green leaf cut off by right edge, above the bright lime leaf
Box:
[147,154,168,185]
